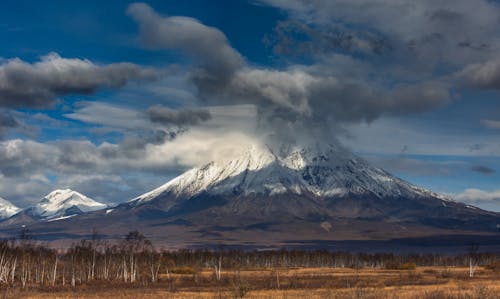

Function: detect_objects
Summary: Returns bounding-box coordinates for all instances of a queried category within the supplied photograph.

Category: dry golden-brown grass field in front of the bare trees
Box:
[2,267,500,299]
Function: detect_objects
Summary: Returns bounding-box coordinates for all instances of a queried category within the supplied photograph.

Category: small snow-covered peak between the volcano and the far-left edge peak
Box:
[28,189,107,219]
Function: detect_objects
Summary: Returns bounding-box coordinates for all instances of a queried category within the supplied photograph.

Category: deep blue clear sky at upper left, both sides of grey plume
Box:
[0,0,285,66]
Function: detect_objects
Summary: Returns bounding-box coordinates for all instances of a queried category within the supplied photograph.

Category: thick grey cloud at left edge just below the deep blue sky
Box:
[0,53,157,108]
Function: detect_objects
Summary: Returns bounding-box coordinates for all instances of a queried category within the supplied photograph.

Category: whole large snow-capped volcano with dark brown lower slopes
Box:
[1,143,500,251]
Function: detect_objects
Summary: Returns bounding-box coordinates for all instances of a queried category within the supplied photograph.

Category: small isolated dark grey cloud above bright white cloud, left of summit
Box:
[148,105,211,126]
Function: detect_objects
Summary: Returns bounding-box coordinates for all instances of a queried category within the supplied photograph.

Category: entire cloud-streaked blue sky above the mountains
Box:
[0,0,500,210]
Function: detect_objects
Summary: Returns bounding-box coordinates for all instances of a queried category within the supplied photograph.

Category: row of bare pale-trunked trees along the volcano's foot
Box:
[0,231,500,288]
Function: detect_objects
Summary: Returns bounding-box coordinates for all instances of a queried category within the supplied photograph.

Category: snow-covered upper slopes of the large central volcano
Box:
[131,144,449,204]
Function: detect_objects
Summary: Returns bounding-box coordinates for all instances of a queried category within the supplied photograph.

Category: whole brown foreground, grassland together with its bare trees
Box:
[0,231,500,299]
